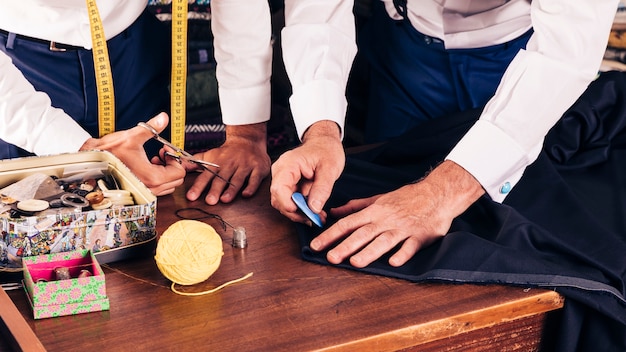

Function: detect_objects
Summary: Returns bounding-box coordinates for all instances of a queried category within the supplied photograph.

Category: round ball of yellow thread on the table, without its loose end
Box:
[154,220,224,285]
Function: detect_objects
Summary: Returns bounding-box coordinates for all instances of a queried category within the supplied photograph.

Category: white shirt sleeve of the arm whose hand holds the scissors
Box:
[0,52,91,155]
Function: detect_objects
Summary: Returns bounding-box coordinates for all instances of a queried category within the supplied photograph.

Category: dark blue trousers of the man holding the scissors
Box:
[0,12,170,159]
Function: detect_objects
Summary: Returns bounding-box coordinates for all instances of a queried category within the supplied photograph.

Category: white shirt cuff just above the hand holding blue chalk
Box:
[289,80,348,140]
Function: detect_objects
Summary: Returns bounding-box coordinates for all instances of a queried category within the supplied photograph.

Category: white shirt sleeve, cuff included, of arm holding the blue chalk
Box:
[282,0,357,138]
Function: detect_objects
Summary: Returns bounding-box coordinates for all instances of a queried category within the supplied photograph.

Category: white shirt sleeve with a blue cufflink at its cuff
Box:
[447,0,617,202]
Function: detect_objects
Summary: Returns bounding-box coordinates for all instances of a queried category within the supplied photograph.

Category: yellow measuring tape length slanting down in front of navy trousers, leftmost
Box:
[87,0,115,137]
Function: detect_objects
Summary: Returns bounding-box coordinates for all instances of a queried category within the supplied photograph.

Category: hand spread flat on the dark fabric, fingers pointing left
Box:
[311,161,484,268]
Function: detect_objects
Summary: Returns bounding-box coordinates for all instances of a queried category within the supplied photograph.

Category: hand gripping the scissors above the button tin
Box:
[80,113,186,196]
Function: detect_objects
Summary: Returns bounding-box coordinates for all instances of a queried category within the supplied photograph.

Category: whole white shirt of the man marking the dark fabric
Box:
[282,0,618,201]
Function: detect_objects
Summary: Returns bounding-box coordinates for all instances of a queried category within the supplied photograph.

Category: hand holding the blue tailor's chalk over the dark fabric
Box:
[270,120,346,223]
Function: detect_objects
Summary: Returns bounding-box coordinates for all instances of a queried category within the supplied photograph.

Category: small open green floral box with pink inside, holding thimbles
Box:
[22,250,109,319]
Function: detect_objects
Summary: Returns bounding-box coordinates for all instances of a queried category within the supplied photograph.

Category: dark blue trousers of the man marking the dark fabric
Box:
[359,1,532,142]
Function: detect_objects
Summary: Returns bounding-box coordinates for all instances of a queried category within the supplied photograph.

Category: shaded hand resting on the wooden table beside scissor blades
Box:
[186,123,271,205]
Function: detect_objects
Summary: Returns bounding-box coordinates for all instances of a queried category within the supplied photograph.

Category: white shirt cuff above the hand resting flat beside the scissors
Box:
[219,84,271,125]
